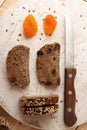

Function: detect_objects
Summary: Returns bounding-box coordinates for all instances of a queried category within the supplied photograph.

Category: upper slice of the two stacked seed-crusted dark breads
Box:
[19,94,59,107]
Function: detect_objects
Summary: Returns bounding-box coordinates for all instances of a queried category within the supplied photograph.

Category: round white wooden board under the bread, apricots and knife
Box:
[0,0,87,130]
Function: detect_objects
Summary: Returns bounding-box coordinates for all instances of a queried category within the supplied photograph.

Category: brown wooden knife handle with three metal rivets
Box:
[64,68,77,126]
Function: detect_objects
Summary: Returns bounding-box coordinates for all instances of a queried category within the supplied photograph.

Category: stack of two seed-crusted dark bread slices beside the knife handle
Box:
[19,94,59,115]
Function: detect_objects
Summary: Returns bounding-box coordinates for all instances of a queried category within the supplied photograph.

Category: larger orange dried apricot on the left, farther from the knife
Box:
[23,14,38,37]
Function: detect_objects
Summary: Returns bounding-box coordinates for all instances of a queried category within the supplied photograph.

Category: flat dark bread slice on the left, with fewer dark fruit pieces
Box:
[6,45,30,88]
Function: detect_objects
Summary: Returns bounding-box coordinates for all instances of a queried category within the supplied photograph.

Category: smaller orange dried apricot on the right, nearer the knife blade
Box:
[43,14,57,35]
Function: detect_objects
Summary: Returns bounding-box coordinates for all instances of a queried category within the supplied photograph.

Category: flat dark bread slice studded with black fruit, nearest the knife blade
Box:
[36,43,60,87]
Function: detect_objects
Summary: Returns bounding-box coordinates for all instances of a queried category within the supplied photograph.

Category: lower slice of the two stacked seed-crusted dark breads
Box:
[21,104,59,116]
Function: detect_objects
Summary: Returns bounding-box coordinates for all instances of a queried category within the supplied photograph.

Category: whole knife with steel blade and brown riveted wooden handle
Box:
[64,15,77,126]
